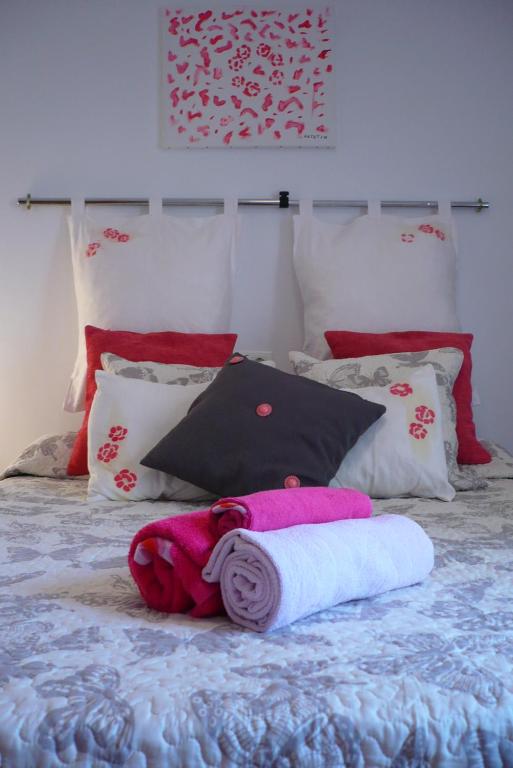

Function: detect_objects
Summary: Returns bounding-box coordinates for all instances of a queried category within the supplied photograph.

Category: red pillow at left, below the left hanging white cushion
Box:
[67,325,237,475]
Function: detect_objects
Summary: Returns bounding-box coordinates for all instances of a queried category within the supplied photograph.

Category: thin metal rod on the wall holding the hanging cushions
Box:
[18,192,490,213]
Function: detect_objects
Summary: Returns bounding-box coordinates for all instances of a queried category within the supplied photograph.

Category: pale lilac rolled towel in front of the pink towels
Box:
[202,515,434,632]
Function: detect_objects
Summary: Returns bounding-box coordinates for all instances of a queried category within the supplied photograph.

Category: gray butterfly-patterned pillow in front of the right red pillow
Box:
[289,347,487,491]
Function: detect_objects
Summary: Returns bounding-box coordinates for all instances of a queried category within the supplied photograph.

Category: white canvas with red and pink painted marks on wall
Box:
[161,8,335,148]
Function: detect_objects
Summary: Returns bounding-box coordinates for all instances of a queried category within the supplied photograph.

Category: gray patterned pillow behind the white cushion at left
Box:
[101,352,275,386]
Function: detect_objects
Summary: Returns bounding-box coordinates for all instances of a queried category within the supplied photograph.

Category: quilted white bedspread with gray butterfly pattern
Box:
[0,477,513,768]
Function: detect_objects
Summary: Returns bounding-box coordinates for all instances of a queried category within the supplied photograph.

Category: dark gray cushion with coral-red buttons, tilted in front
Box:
[141,355,385,496]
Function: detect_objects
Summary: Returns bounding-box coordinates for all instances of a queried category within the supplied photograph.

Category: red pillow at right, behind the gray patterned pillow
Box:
[324,331,492,464]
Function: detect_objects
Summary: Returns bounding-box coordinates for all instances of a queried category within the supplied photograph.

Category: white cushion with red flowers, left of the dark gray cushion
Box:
[88,371,209,501]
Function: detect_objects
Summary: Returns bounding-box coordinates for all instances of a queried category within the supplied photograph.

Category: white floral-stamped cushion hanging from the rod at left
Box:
[64,204,237,411]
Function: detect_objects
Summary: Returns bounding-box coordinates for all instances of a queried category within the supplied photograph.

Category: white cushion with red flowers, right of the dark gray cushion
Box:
[330,365,455,501]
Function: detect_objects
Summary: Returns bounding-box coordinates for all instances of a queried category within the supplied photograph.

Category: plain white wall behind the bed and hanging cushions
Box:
[0,0,513,465]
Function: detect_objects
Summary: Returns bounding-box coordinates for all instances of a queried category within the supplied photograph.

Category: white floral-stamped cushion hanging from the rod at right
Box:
[294,206,460,359]
